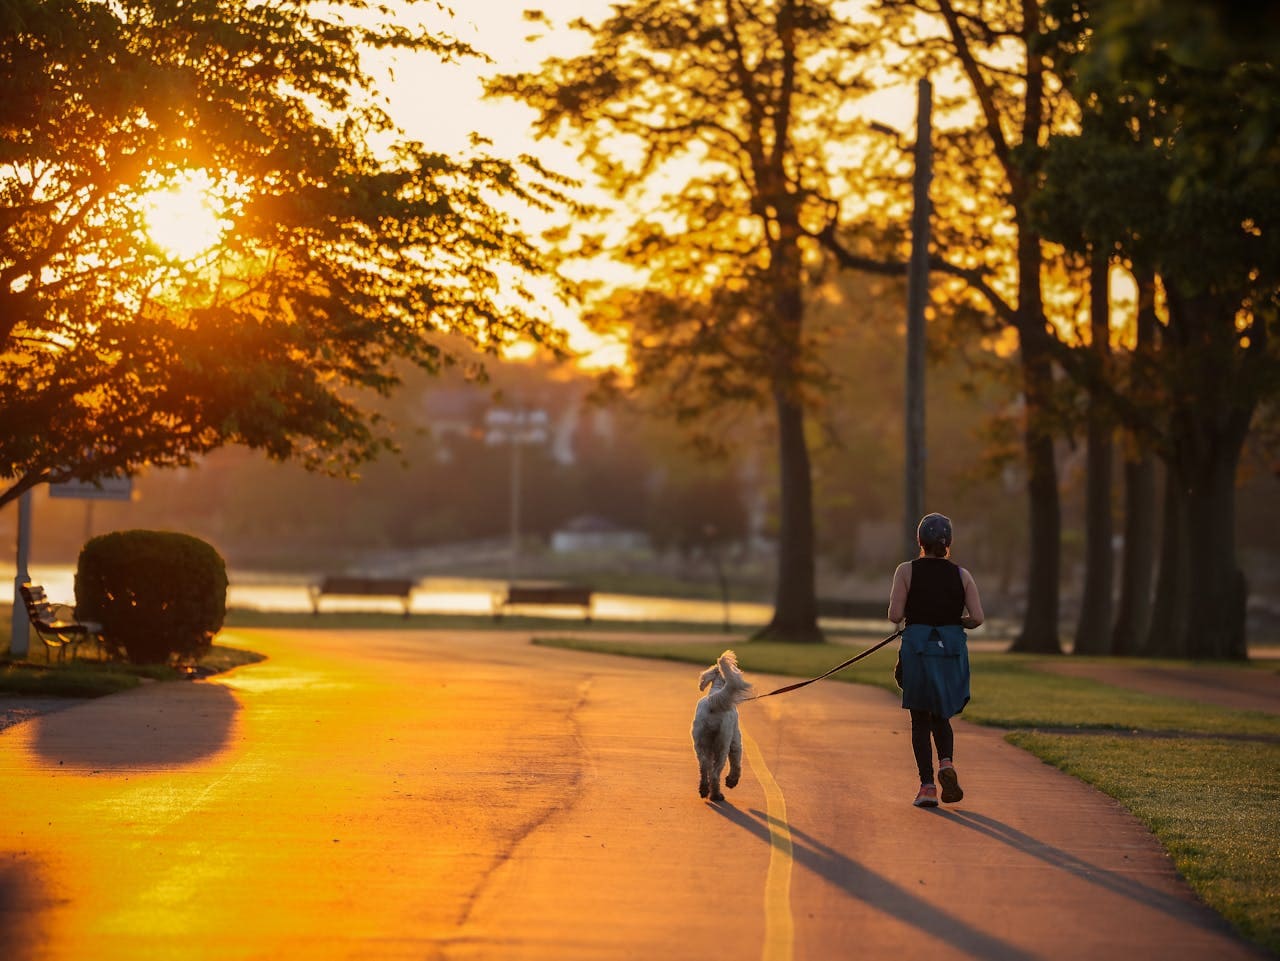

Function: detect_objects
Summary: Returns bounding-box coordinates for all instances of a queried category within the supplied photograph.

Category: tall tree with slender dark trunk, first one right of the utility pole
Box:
[823,0,1070,654]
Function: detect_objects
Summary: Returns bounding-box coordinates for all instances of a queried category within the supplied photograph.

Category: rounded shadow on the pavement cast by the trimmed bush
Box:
[32,681,239,770]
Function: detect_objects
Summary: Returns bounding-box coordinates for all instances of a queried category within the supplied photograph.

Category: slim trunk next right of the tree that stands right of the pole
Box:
[1073,247,1114,654]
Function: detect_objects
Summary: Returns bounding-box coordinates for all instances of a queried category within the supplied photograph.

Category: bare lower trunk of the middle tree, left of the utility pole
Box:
[755,392,824,642]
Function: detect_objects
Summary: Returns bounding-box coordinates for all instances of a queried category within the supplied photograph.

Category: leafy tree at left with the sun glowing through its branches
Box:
[0,0,562,504]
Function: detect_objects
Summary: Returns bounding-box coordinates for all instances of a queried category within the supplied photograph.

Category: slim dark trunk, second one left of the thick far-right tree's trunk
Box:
[1111,269,1157,655]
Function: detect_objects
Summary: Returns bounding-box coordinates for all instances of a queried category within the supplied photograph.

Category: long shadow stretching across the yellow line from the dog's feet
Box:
[710,801,1036,961]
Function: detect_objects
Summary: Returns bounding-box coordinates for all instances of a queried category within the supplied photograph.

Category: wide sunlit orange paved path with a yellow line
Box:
[0,631,1261,961]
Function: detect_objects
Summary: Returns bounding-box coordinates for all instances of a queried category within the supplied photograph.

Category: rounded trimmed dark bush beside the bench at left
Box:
[76,531,227,664]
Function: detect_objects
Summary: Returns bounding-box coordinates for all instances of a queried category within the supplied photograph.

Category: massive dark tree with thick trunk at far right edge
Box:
[1043,4,1280,658]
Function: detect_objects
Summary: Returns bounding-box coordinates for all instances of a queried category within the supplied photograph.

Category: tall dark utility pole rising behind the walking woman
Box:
[904,78,933,558]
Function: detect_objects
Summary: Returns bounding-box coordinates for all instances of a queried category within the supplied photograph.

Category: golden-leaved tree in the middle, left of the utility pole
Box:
[488,0,880,641]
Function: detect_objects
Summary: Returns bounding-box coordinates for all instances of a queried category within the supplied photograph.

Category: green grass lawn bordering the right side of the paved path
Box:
[534,637,1280,955]
